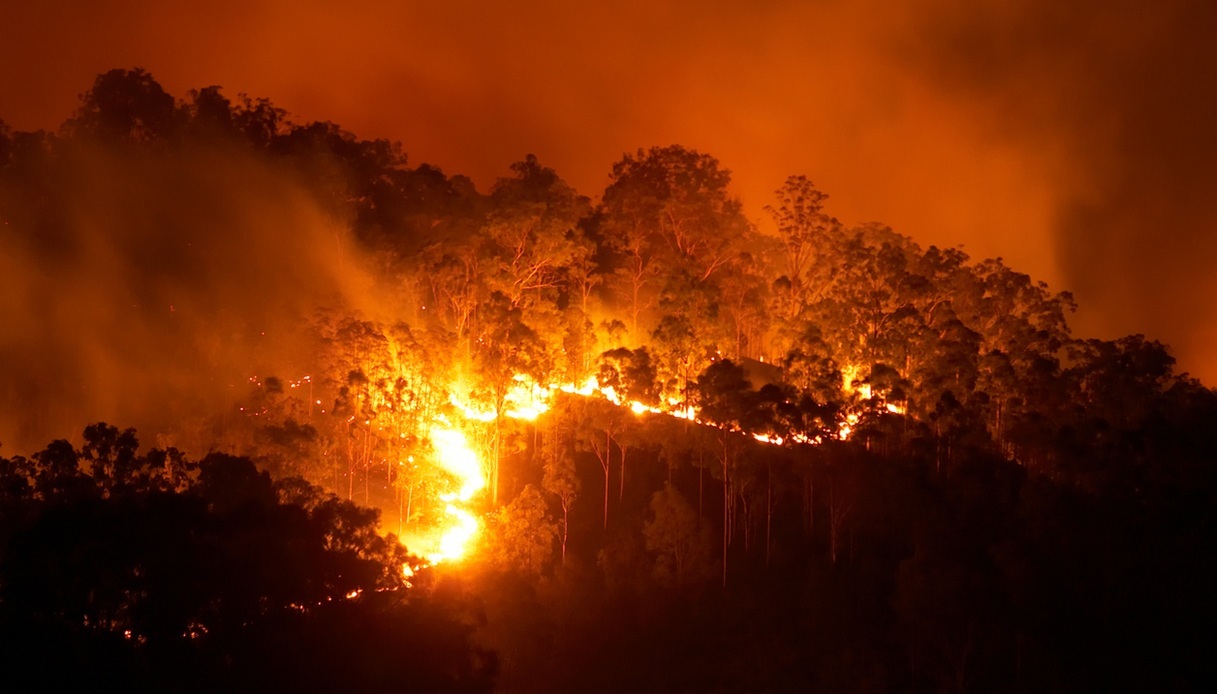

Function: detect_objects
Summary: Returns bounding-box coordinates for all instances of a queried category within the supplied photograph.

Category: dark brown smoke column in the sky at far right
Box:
[907,0,1217,384]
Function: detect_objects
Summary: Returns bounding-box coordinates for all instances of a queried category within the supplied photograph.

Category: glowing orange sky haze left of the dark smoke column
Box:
[0,0,1059,275]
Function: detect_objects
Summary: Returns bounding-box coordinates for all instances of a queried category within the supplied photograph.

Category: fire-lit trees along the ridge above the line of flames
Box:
[0,69,1207,496]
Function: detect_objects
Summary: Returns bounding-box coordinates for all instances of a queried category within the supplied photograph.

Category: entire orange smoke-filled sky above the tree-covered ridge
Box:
[7,0,1217,385]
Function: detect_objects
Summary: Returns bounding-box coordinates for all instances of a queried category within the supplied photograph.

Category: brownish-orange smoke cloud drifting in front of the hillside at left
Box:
[0,145,366,455]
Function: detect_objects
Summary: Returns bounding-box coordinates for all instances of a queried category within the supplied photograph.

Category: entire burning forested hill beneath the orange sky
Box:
[0,69,1217,690]
